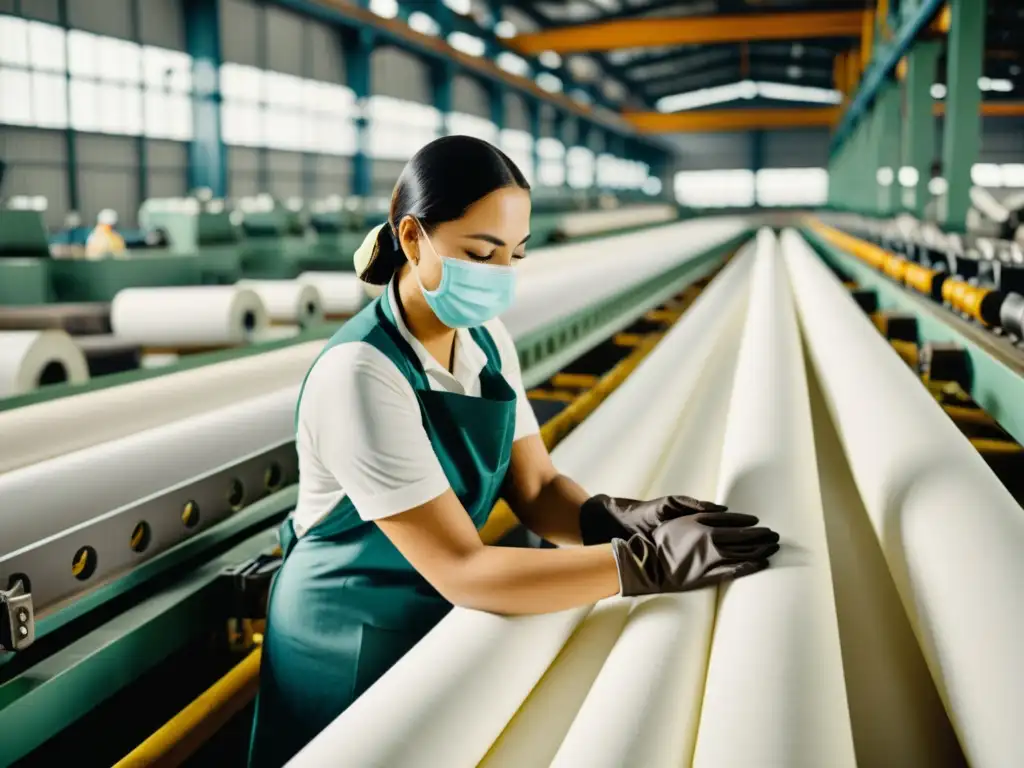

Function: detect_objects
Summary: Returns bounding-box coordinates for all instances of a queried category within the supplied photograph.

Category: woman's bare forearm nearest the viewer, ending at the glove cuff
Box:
[445,545,620,614]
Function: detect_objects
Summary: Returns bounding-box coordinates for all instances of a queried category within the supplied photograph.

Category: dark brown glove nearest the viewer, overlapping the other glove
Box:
[611,512,779,597]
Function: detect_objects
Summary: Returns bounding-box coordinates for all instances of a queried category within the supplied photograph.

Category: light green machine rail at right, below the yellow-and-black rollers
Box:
[803,229,1024,442]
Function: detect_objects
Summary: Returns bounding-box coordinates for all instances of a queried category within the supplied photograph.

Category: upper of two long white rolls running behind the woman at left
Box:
[0,341,324,475]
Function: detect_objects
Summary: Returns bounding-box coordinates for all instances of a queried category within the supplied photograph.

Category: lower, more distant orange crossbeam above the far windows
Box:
[623,106,841,133]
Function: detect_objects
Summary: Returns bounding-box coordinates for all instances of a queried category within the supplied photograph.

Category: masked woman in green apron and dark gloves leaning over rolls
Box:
[250,136,778,768]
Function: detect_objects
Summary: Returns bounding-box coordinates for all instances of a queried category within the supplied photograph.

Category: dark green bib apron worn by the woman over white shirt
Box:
[249,294,516,768]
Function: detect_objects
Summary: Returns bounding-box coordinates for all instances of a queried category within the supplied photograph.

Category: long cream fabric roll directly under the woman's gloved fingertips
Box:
[693,230,856,768]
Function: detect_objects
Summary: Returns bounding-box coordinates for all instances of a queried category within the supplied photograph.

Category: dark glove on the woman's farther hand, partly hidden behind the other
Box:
[580,495,733,546]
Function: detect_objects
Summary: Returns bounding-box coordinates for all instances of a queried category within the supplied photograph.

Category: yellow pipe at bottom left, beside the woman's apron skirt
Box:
[114,648,261,768]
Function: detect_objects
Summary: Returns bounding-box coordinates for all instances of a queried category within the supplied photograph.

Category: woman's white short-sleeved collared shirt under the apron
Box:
[292,283,540,536]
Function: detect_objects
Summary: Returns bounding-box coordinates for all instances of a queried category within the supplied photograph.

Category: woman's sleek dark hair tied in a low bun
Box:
[359,136,529,286]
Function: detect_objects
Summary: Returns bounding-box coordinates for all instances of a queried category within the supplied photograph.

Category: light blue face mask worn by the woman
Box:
[416,226,515,328]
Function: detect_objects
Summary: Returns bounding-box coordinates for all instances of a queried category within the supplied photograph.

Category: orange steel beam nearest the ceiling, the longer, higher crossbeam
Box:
[508,10,865,55]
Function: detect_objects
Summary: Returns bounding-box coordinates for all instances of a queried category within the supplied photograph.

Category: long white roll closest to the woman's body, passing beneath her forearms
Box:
[289,240,746,768]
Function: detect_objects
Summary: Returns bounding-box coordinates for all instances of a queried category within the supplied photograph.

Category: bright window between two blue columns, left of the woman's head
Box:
[220,63,356,155]
